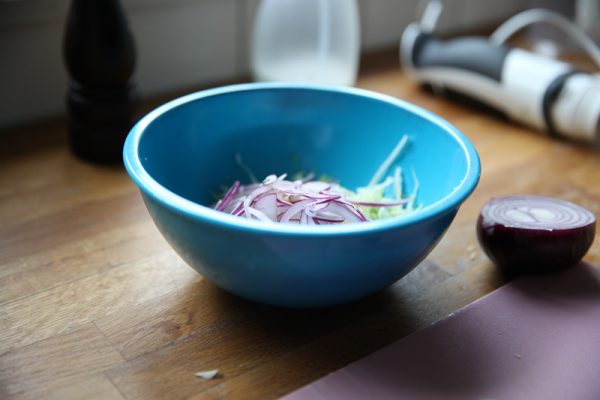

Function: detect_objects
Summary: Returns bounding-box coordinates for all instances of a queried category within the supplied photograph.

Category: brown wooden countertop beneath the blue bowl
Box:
[0,57,600,399]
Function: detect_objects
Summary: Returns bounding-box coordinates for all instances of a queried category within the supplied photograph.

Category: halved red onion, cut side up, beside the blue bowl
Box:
[477,195,596,274]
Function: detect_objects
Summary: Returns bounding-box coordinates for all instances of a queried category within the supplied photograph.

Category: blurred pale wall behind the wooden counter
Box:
[0,0,523,129]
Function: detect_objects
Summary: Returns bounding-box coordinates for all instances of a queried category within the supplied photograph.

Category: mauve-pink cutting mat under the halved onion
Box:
[282,263,600,400]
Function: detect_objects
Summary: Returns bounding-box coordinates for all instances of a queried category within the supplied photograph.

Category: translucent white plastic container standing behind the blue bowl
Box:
[251,0,360,85]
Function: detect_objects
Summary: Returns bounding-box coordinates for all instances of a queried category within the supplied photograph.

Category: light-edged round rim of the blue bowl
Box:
[123,82,481,236]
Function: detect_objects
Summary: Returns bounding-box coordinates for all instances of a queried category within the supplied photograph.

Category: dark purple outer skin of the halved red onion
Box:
[477,214,596,275]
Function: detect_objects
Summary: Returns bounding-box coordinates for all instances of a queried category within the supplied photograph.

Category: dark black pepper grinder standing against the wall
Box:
[63,0,137,163]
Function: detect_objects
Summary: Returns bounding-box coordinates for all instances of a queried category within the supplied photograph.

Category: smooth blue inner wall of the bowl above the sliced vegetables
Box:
[138,86,476,216]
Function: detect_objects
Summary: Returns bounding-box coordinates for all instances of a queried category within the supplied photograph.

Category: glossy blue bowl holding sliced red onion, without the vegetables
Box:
[124,83,480,307]
